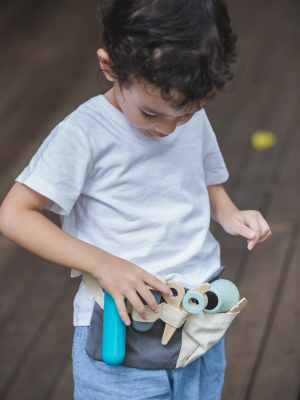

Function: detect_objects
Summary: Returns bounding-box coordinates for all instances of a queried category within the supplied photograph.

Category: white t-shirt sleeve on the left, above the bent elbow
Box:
[15,121,92,215]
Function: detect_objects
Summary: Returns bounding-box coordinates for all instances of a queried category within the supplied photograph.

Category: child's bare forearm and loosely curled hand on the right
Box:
[207,185,271,250]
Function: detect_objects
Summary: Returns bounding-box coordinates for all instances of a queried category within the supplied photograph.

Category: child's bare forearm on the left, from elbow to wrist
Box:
[0,210,113,275]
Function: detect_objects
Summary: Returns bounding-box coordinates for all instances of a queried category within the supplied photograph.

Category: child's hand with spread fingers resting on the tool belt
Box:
[91,254,173,325]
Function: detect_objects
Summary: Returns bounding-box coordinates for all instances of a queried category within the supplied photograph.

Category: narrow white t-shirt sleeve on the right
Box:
[202,110,229,186]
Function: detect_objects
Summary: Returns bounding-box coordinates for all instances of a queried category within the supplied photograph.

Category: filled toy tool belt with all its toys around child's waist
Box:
[83,267,247,369]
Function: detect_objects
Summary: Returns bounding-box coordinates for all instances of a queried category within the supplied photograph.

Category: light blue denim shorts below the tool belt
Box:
[72,326,226,400]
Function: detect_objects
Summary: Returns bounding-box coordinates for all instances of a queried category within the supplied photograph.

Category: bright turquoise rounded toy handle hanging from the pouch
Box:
[102,290,126,365]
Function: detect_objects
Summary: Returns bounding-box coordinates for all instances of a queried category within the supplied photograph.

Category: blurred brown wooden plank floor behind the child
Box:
[0,0,300,400]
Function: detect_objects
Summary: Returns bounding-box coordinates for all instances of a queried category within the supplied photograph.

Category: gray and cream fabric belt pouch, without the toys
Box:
[83,274,239,369]
